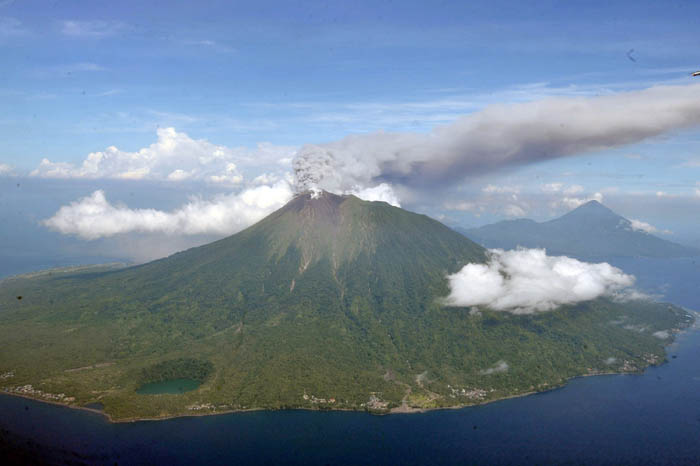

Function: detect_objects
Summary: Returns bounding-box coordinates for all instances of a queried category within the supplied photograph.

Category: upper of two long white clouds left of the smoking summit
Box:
[31,128,294,185]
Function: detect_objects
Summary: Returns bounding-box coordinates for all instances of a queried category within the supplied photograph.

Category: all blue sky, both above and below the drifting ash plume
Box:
[0,0,700,260]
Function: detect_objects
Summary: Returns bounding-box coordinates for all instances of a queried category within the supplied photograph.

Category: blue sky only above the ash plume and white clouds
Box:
[0,1,700,157]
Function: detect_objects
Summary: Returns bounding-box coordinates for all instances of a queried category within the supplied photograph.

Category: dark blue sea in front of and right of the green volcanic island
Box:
[0,259,700,465]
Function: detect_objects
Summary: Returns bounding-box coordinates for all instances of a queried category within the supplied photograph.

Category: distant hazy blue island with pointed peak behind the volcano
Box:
[456,201,700,260]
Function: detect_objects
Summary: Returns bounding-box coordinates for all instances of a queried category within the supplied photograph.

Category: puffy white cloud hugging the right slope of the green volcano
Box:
[444,249,634,314]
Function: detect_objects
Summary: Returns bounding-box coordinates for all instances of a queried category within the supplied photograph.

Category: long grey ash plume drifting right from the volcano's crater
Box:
[293,84,700,192]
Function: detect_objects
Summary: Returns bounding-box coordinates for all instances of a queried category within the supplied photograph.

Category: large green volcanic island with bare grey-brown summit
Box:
[0,193,692,419]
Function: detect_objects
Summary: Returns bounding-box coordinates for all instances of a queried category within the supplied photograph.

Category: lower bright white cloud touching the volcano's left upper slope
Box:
[43,181,293,240]
